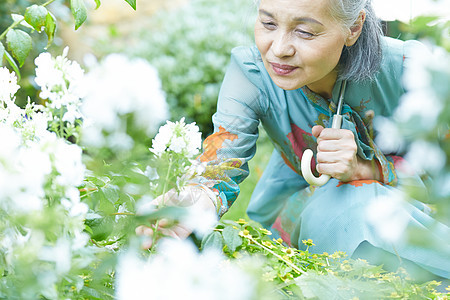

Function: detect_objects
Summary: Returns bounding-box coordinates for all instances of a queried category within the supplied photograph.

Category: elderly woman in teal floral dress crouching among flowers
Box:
[139,0,450,278]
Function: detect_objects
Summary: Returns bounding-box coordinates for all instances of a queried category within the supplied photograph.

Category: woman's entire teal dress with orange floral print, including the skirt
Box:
[194,38,450,278]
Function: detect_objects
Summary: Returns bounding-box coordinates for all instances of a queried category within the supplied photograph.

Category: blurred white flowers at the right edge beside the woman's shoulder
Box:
[375,47,450,174]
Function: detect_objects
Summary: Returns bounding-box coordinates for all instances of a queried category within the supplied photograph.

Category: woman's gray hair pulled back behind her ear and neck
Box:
[330,0,383,81]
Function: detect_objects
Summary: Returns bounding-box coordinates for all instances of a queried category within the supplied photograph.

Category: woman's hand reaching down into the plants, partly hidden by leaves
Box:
[136,186,216,249]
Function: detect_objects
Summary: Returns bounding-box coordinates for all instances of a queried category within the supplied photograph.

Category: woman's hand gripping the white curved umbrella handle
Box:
[312,125,380,182]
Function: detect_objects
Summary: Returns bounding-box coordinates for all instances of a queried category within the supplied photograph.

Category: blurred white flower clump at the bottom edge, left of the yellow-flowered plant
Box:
[116,240,255,300]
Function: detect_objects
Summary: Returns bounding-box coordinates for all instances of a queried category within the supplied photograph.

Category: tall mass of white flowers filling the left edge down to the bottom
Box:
[0,62,92,299]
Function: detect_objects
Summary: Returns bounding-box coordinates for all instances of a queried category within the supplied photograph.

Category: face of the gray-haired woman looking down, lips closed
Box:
[255,0,347,97]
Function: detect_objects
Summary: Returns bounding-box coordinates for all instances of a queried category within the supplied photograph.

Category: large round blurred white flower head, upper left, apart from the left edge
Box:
[81,54,168,150]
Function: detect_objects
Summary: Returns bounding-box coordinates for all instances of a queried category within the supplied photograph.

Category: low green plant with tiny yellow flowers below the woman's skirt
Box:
[201,219,445,299]
